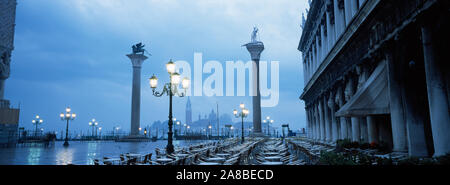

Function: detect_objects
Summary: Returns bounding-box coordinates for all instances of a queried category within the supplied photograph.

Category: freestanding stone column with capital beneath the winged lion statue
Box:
[127,54,147,136]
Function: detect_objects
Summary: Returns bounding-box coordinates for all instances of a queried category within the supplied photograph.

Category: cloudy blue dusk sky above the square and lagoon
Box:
[5,0,308,131]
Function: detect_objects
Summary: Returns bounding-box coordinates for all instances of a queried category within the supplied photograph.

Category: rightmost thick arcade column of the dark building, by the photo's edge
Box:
[422,23,450,156]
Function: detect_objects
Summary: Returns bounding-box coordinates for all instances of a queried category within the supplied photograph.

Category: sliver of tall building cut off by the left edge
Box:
[0,0,19,145]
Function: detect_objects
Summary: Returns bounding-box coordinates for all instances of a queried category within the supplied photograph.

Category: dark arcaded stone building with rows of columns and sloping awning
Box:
[298,0,450,157]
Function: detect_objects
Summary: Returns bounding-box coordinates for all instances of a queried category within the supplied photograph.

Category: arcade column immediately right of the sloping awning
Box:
[385,48,408,152]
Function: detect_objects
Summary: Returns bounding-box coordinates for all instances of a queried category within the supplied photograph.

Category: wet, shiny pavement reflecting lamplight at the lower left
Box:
[0,140,205,165]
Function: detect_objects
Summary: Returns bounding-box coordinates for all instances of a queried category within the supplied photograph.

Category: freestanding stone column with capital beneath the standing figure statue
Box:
[246,42,264,136]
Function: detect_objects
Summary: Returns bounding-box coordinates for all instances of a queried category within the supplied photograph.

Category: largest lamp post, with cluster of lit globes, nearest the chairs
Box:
[150,60,190,154]
